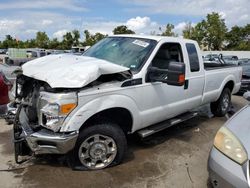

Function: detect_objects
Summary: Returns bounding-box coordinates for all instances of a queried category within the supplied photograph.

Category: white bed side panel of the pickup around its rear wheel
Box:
[202,67,241,104]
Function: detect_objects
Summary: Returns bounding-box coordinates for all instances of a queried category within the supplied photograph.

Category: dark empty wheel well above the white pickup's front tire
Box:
[80,108,133,134]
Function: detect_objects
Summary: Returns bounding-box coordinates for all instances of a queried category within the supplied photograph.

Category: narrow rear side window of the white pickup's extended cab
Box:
[186,43,200,72]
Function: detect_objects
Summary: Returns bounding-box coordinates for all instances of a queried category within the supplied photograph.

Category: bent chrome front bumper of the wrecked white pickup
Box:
[19,109,78,154]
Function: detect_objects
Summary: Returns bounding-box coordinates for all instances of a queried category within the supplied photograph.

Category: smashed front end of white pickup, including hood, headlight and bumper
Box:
[14,55,132,162]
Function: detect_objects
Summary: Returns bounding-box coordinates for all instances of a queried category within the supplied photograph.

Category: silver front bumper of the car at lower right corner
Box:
[208,147,249,188]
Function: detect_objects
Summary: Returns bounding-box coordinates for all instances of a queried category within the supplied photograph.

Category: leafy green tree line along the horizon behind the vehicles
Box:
[0,12,250,50]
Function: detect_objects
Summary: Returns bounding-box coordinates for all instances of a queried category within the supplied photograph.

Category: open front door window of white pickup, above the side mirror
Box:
[152,43,183,69]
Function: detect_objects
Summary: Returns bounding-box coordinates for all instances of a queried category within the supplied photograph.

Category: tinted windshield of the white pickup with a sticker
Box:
[83,37,157,71]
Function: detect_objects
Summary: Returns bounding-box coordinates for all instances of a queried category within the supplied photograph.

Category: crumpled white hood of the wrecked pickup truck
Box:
[22,54,129,88]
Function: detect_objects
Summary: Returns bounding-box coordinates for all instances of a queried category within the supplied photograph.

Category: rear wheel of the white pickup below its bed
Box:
[210,88,231,117]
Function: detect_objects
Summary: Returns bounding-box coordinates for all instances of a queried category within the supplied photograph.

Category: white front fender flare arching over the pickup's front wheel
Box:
[61,94,141,132]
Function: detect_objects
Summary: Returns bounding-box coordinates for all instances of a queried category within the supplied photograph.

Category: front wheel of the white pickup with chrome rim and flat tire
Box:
[71,123,127,170]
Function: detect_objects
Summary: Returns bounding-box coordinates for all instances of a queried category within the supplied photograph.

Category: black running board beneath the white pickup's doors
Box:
[137,112,198,138]
